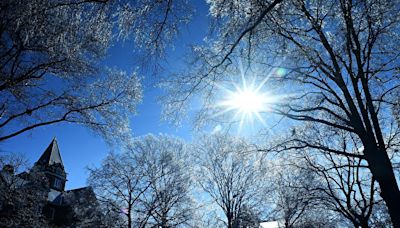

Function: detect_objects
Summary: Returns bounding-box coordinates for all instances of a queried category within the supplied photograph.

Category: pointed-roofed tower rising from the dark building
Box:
[33,138,67,192]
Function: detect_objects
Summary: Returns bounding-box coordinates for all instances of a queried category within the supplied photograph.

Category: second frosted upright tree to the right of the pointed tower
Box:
[129,135,195,228]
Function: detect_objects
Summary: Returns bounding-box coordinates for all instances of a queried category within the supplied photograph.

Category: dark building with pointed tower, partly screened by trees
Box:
[0,138,103,227]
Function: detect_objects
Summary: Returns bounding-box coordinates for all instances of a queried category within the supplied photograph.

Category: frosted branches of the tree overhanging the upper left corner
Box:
[0,0,190,141]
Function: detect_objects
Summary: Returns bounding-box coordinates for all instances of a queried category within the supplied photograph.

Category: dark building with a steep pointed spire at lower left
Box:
[0,138,102,227]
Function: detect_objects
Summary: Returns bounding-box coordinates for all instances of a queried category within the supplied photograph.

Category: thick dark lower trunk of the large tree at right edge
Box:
[364,145,400,228]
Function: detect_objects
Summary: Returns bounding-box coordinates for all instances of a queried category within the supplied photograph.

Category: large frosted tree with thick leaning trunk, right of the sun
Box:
[162,0,400,224]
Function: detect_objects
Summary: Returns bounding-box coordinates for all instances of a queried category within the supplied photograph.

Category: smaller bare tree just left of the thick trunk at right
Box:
[296,132,387,227]
